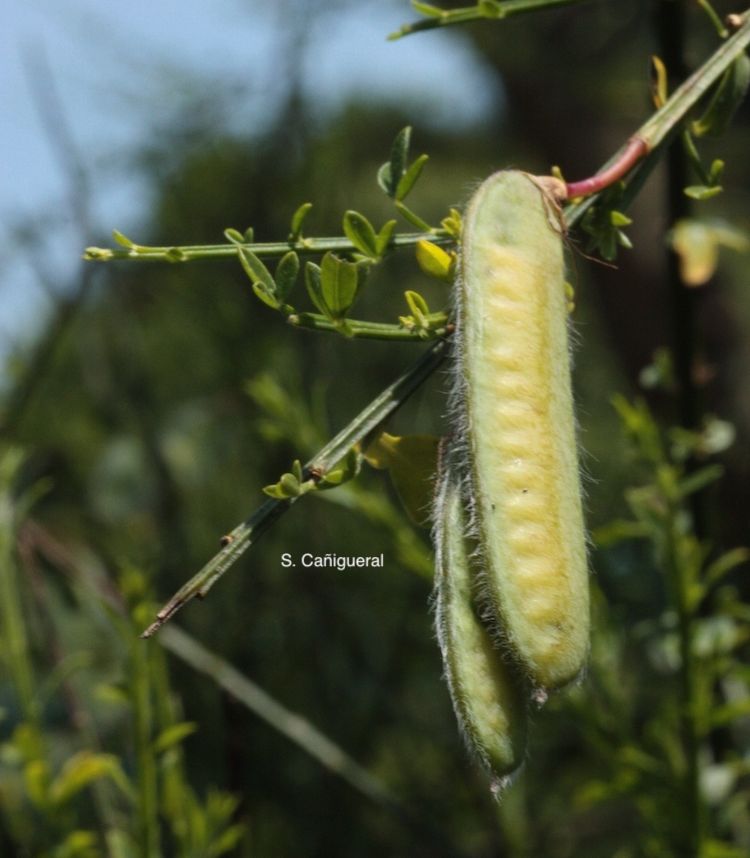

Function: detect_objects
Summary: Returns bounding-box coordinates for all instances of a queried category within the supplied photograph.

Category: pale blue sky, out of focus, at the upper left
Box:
[0,0,506,357]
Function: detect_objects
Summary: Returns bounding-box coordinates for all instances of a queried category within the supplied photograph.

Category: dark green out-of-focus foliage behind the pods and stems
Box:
[0,0,750,858]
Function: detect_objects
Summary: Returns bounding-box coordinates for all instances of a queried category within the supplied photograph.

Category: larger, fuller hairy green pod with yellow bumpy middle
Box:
[457,170,589,689]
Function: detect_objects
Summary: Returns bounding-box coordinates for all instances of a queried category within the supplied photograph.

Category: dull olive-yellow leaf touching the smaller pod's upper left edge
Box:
[364,432,440,527]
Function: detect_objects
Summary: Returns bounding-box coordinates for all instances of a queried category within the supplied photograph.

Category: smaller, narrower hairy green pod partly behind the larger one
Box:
[434,462,528,792]
